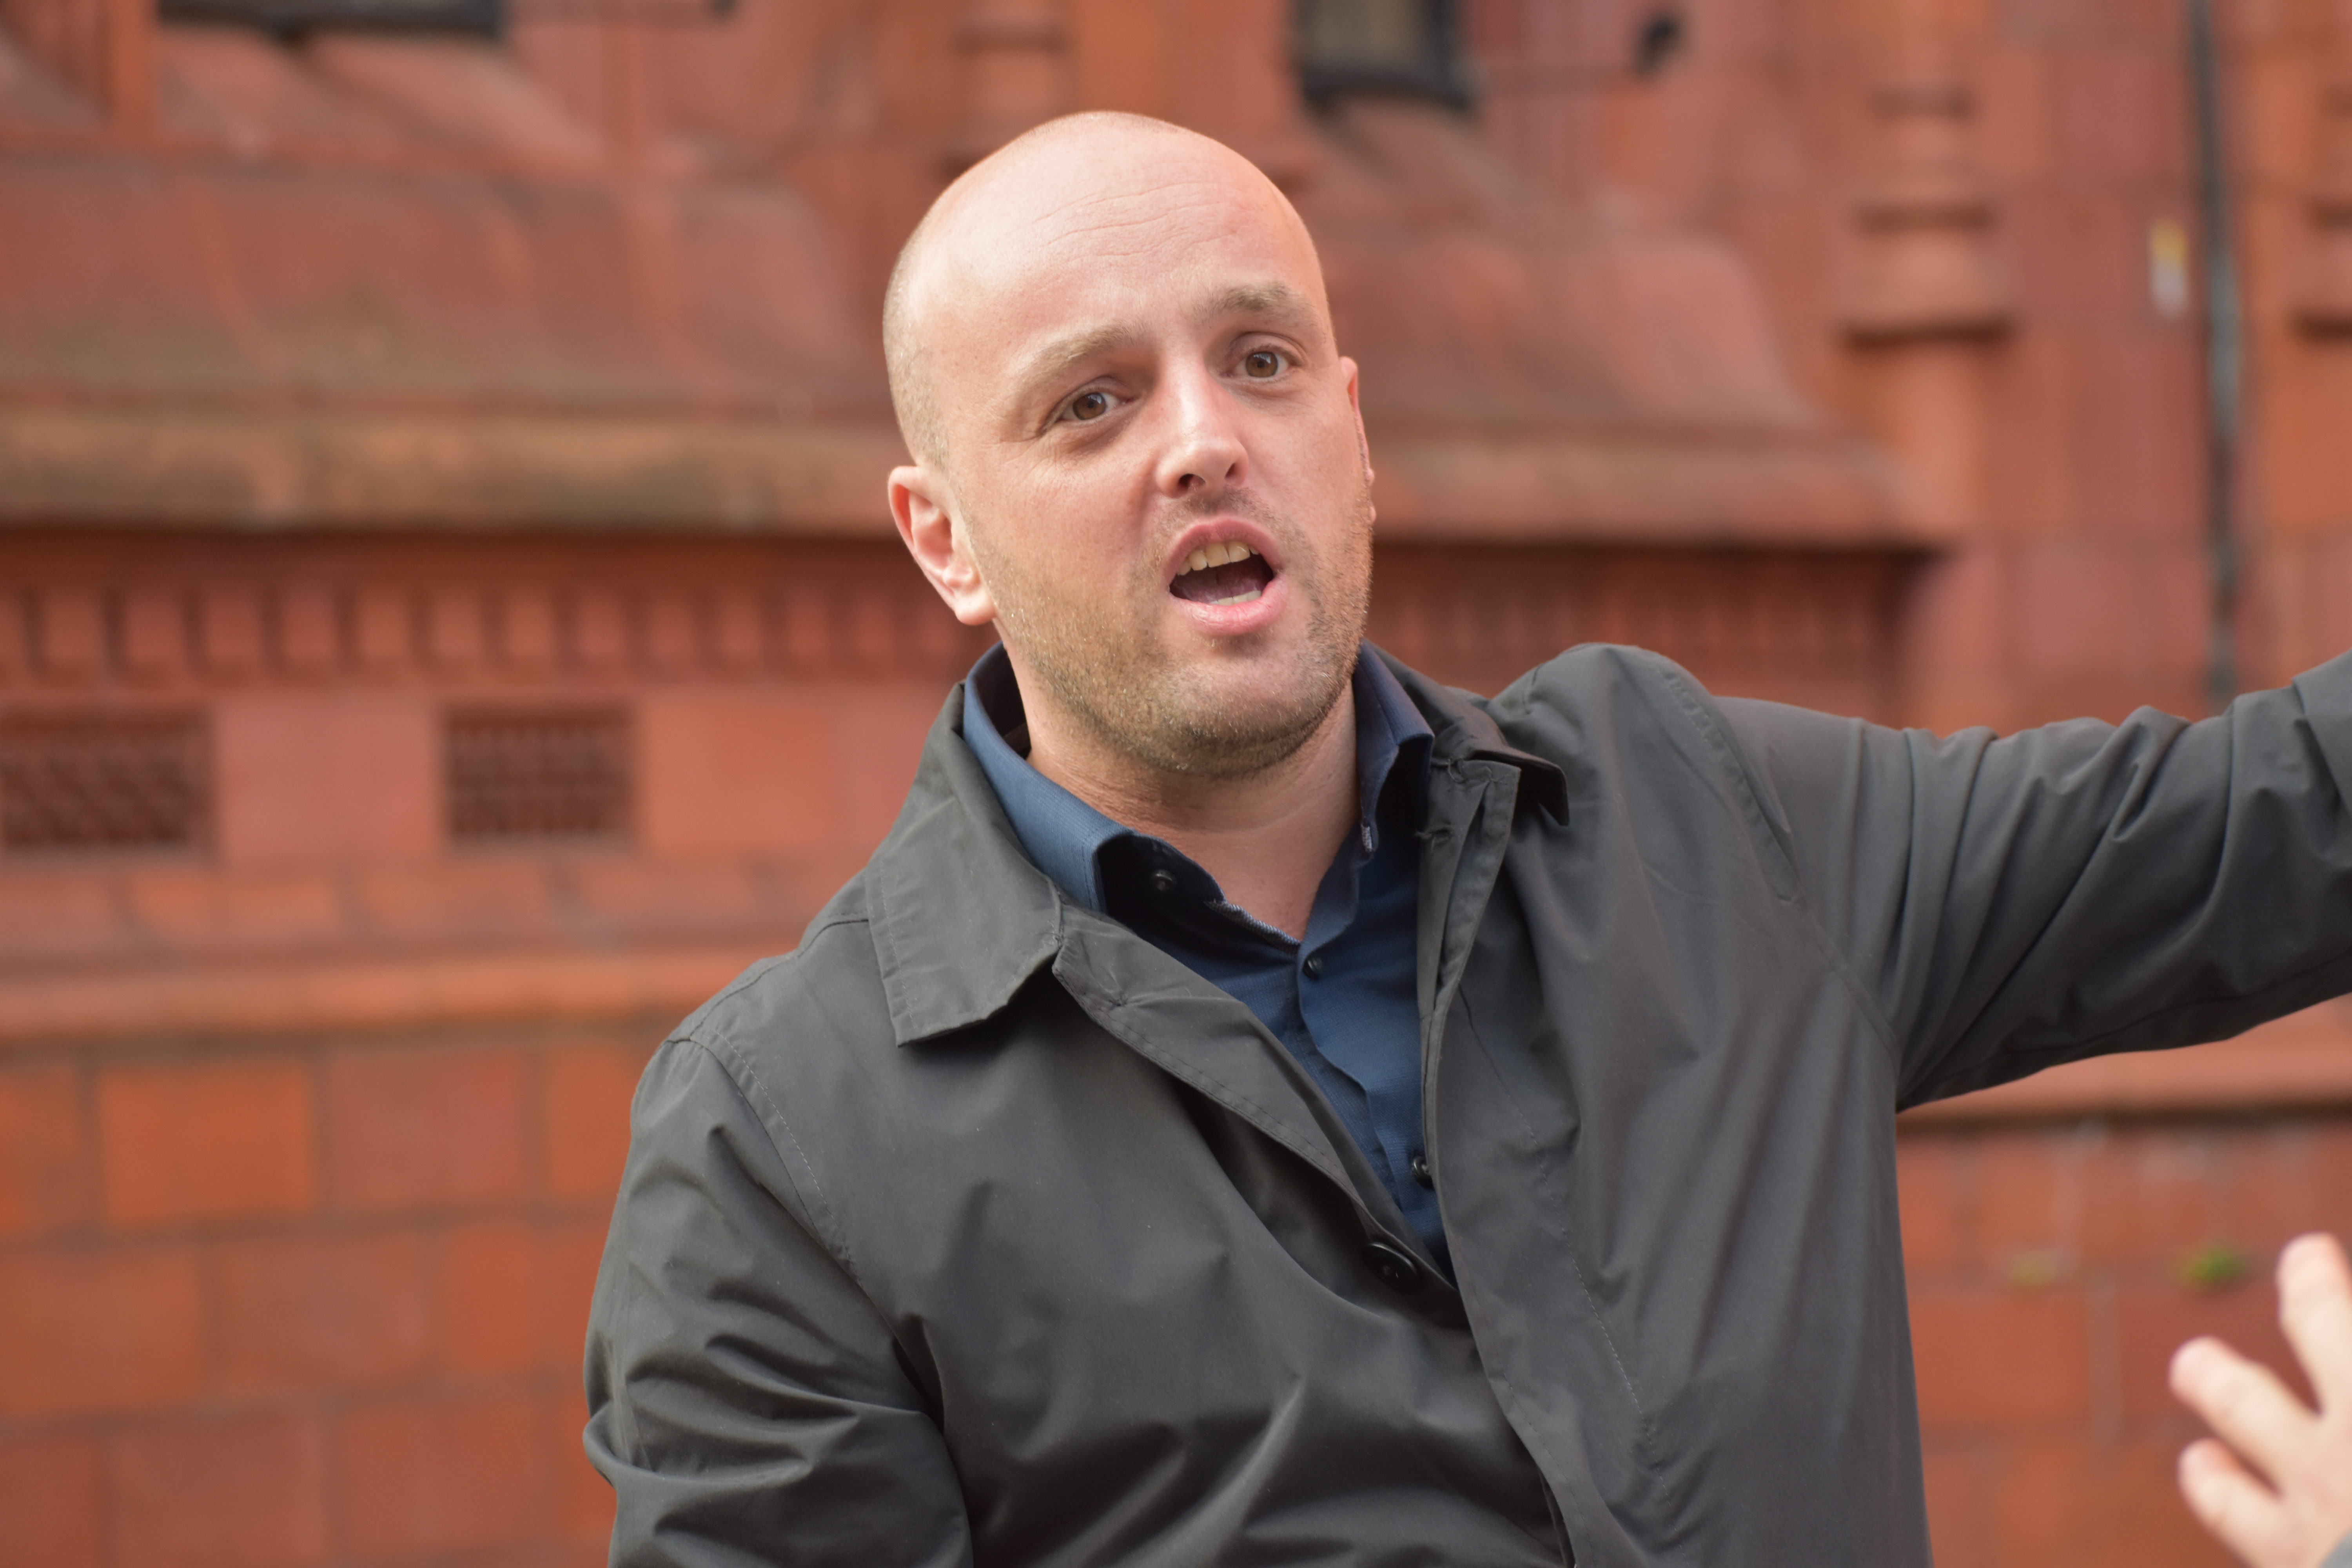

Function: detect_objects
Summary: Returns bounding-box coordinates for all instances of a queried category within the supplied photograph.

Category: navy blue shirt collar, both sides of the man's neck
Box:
[964,644,1432,912]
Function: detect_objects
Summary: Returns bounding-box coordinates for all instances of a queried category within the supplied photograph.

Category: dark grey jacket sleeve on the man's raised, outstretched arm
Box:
[1722,656,2352,1105]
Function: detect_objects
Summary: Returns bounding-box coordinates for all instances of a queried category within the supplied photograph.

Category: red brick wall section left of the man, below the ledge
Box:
[0,1020,666,1568]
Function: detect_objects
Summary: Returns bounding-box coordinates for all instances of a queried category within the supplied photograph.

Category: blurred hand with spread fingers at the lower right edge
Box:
[2173,1236,2352,1568]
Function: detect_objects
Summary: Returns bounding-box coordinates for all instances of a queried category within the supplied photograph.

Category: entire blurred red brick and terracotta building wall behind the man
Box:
[0,0,2352,1568]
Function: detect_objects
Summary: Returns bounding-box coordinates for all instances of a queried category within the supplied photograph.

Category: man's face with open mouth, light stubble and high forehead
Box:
[903,139,1371,776]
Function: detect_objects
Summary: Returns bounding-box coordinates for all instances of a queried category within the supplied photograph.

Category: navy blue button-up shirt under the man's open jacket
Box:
[964,646,1444,1260]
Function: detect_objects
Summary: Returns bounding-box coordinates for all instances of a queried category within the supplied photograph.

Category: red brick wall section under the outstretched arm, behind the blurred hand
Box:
[1900,1114,2352,1568]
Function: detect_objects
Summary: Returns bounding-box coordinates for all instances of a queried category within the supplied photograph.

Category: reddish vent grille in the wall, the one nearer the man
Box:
[442,708,633,844]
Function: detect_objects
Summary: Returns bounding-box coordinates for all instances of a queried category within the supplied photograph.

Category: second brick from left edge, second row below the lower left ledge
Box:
[212,1234,433,1394]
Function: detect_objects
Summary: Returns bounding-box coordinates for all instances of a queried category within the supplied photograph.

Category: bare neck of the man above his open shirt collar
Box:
[1030,691,1359,938]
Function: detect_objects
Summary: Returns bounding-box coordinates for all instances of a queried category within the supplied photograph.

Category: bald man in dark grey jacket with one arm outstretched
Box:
[588,115,2352,1568]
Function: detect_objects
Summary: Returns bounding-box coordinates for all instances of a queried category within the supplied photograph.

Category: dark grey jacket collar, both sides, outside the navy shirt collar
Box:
[868,644,1569,1046]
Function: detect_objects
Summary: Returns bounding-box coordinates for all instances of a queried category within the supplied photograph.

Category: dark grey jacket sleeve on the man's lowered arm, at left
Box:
[586,1037,971,1568]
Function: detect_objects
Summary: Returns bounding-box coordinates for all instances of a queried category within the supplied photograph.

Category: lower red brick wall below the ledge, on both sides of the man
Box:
[14,1018,2352,1568]
